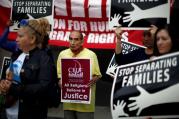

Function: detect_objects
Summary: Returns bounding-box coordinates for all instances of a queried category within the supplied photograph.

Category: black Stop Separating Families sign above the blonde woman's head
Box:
[10,0,54,31]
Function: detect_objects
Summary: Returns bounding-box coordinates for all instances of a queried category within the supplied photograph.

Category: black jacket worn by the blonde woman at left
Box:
[9,48,53,119]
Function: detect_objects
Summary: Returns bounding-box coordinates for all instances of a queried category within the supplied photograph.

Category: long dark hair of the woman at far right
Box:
[154,25,179,56]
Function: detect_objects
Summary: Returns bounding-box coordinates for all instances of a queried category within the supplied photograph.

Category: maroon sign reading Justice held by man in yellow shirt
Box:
[61,58,91,104]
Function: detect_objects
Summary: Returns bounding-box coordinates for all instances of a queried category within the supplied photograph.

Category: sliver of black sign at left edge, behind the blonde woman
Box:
[1,57,10,79]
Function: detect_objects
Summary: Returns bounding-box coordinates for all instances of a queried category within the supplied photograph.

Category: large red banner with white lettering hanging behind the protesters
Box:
[0,0,143,49]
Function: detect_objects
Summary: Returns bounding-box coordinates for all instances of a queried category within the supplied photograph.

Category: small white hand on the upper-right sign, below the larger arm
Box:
[109,14,121,29]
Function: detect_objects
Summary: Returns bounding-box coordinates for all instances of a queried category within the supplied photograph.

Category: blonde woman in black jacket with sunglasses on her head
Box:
[0,20,53,119]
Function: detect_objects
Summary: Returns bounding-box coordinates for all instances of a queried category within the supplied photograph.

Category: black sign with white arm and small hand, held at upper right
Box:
[109,0,170,30]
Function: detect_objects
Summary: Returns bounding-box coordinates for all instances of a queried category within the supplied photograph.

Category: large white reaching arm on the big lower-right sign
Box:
[128,83,179,115]
